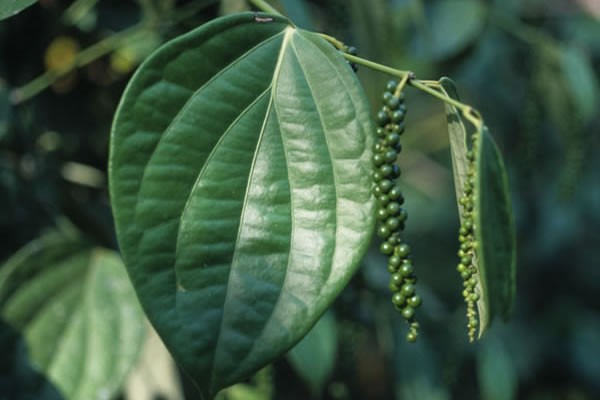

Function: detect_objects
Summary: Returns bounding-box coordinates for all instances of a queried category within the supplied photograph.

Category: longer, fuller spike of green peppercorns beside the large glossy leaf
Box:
[373,81,421,342]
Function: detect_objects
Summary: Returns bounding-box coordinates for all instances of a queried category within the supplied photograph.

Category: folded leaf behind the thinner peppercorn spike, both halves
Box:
[440,78,516,337]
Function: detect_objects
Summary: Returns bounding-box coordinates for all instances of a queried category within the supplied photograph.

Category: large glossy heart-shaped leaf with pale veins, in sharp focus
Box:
[109,13,373,397]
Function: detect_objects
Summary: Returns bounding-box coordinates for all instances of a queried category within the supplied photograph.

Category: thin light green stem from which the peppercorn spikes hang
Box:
[249,0,483,129]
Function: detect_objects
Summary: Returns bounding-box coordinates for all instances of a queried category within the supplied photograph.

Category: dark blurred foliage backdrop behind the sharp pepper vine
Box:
[0,0,600,400]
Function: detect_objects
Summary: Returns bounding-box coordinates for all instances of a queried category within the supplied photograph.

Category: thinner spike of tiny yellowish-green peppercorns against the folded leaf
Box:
[456,127,480,342]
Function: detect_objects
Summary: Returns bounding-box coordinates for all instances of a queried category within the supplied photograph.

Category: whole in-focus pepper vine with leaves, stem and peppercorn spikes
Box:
[0,0,515,399]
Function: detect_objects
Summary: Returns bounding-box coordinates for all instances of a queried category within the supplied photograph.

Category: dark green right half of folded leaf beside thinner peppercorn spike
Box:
[474,127,516,324]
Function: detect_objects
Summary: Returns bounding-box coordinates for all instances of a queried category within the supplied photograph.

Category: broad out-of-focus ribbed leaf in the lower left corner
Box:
[0,235,145,399]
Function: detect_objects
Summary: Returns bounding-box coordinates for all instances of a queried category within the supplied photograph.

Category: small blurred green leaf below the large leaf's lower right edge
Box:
[287,312,337,397]
